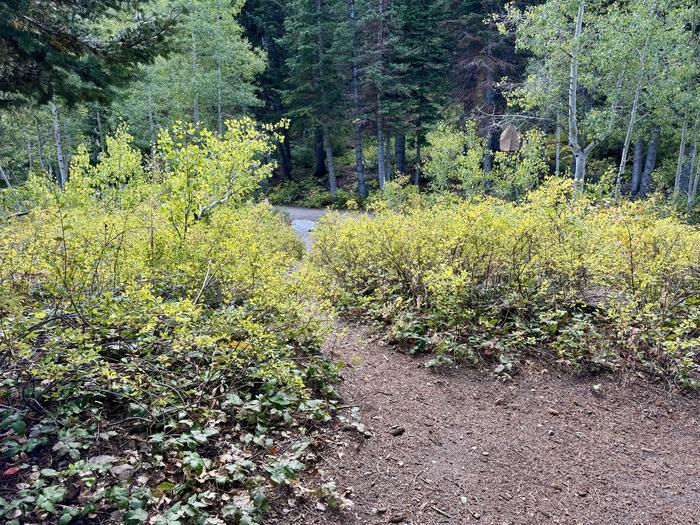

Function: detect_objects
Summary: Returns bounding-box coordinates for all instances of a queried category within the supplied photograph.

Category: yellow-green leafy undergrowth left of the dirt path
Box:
[0,122,337,525]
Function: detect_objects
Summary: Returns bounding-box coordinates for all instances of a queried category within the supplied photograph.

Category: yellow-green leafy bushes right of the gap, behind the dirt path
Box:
[311,181,700,388]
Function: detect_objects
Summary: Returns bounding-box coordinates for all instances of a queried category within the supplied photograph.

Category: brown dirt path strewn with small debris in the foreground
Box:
[266,327,700,525]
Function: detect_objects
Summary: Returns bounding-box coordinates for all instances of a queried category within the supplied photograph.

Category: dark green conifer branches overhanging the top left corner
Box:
[0,0,179,106]
